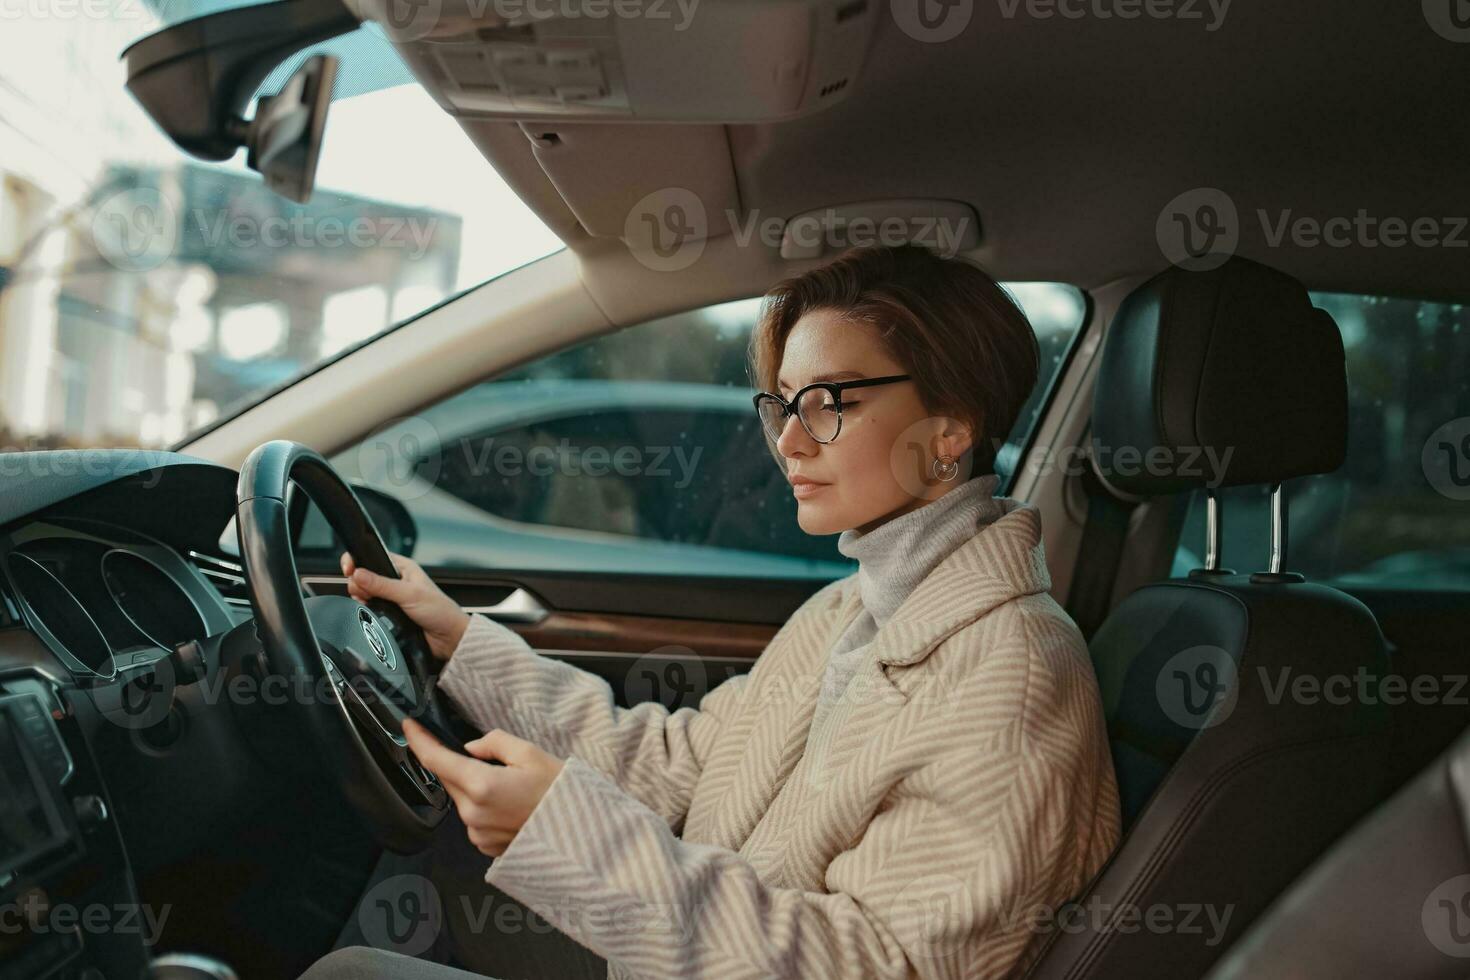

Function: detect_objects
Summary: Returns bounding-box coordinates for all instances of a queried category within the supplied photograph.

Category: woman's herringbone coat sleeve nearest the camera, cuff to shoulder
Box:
[485,614,1116,979]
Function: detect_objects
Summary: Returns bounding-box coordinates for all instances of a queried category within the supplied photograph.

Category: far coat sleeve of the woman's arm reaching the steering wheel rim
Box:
[440,616,747,827]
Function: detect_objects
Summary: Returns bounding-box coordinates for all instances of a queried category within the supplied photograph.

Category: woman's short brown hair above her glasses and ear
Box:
[750,245,1041,476]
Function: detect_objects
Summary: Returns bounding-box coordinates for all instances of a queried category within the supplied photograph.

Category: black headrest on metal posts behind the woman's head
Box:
[1092,257,1348,497]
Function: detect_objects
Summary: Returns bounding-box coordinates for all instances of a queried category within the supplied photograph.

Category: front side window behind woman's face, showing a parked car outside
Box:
[334,284,1086,579]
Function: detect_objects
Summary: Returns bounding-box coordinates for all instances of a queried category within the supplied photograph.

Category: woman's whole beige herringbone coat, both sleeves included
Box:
[442,500,1119,977]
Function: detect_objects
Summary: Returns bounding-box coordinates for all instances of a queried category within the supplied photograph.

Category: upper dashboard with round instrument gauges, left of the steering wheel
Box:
[0,451,248,686]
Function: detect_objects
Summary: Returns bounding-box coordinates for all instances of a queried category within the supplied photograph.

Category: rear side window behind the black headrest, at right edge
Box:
[1173,294,1470,589]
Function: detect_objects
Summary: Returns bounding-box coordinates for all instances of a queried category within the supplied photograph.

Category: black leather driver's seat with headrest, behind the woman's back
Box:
[1028,259,1389,980]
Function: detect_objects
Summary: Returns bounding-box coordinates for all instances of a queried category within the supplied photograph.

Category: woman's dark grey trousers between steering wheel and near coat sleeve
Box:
[301,811,607,980]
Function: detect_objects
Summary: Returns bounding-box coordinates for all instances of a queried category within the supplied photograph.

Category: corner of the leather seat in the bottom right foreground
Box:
[1210,725,1470,980]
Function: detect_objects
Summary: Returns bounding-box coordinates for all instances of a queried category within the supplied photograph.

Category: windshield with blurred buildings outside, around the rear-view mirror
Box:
[0,0,562,448]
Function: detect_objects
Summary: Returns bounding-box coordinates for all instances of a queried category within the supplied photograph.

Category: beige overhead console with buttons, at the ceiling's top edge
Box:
[345,0,879,122]
